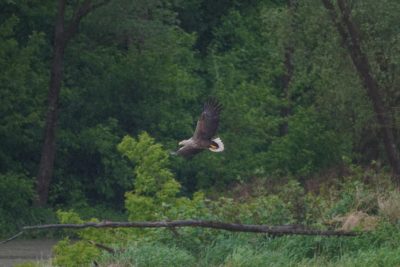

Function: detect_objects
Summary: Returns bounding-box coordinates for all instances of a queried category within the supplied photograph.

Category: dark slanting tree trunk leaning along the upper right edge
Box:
[322,0,400,184]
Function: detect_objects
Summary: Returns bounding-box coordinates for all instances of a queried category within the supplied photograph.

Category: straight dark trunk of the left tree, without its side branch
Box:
[37,0,65,206]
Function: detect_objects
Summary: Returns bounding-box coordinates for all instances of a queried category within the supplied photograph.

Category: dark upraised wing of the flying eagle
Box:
[193,99,222,140]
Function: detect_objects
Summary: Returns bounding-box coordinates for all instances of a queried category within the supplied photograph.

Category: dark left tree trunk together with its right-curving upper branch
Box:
[37,0,108,206]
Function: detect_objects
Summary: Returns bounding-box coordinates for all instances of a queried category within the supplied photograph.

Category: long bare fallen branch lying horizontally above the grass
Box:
[0,220,357,244]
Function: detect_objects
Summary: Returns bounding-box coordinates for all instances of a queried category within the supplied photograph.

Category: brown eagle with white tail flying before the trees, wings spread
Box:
[176,99,224,158]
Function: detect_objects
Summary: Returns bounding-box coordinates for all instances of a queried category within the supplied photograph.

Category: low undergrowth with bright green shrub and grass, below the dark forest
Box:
[16,134,400,267]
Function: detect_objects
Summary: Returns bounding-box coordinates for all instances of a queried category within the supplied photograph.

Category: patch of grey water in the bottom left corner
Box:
[0,239,57,267]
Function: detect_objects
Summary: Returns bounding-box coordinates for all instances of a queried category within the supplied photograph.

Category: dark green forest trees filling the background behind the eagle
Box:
[0,0,400,233]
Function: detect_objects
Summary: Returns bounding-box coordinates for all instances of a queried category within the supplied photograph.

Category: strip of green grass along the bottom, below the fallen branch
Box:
[91,226,400,267]
